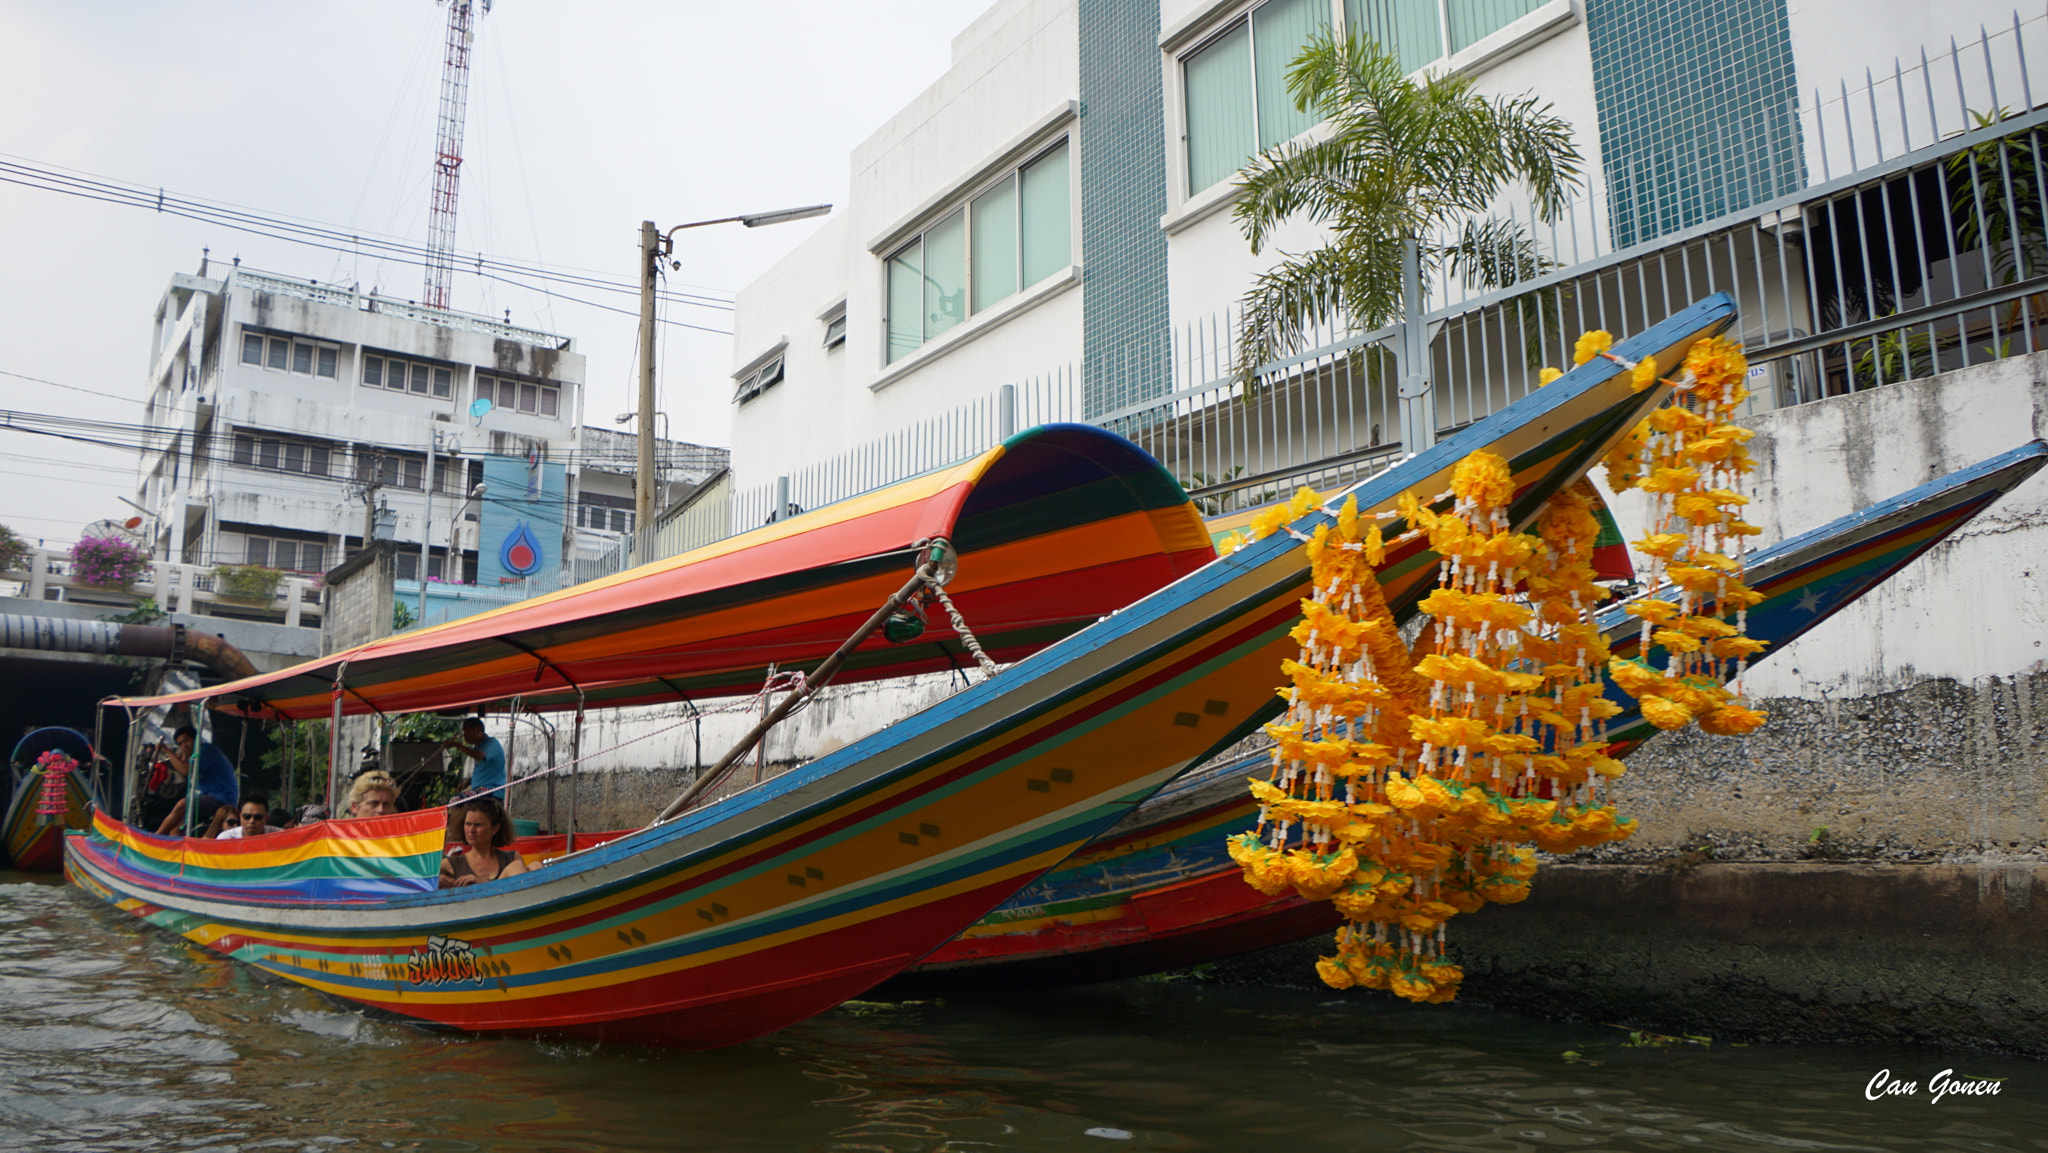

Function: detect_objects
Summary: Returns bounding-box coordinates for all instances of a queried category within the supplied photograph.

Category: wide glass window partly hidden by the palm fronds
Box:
[1182,0,1546,195]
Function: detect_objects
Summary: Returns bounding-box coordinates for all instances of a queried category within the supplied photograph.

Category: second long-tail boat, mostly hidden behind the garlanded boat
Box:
[879,440,2048,997]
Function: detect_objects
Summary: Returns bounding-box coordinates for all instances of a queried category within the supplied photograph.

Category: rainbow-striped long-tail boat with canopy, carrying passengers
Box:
[68,295,1735,1049]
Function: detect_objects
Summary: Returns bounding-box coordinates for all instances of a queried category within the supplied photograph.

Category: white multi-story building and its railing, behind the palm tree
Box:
[733,0,2048,507]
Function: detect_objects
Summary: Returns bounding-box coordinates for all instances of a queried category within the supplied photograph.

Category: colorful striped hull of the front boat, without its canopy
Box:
[68,297,1735,1049]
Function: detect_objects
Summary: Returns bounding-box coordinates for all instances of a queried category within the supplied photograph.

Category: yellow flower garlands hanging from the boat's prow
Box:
[1227,332,1761,1001]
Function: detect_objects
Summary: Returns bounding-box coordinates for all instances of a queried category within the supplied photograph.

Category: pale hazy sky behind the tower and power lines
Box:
[0,0,987,547]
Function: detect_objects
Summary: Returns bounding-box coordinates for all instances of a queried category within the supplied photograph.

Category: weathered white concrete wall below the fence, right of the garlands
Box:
[1599,354,2048,862]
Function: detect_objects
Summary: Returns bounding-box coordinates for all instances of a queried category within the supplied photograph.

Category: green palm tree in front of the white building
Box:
[1235,33,1581,451]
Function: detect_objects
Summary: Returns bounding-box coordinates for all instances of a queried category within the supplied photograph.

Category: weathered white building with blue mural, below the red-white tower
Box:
[137,266,584,618]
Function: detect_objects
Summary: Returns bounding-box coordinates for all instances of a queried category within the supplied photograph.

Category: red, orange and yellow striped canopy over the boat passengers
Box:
[119,424,1214,719]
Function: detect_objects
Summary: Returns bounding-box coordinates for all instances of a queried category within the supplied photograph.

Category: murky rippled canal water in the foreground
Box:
[0,874,2048,1153]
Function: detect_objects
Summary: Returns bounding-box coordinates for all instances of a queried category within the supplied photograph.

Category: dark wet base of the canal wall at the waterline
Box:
[1210,860,2048,1057]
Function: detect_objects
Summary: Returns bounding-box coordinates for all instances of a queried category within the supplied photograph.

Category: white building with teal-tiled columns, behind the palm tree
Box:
[733,0,2048,495]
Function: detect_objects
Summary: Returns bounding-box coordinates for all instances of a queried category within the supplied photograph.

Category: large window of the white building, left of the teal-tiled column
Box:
[887,139,1073,362]
